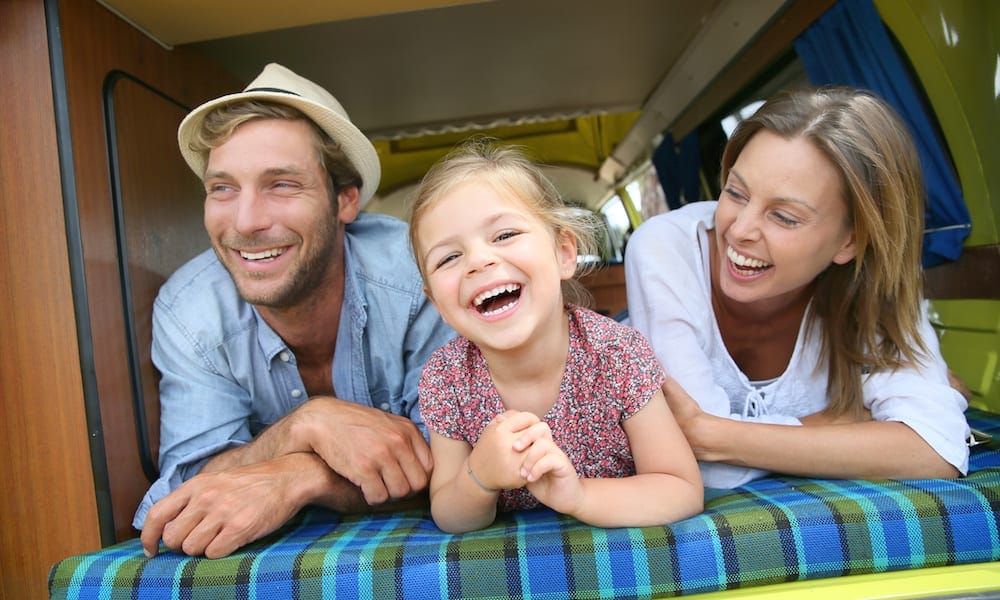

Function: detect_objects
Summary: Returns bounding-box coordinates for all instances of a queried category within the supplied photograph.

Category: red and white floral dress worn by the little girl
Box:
[419,305,664,510]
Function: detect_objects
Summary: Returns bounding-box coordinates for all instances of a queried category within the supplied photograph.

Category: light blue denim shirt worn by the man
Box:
[132,213,455,529]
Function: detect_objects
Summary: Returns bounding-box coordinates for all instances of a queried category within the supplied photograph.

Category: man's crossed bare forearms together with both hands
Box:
[142,397,433,558]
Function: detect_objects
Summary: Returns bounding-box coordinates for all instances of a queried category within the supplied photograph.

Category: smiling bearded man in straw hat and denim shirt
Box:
[133,64,454,558]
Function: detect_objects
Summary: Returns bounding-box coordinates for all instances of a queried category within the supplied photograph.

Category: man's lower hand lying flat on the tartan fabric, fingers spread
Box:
[141,454,332,558]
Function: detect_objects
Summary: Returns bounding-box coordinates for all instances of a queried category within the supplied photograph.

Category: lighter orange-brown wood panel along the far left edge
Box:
[0,0,100,599]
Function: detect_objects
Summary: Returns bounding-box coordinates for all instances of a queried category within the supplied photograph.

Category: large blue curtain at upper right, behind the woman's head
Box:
[795,0,972,267]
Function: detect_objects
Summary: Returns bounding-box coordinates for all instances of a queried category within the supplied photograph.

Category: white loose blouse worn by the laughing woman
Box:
[625,202,969,488]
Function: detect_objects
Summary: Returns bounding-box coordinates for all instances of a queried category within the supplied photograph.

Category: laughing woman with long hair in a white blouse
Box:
[625,88,968,488]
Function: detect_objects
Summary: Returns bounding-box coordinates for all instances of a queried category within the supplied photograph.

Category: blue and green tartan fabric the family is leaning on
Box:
[49,410,1000,600]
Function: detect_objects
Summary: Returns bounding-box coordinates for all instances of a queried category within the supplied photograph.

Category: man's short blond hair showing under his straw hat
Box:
[188,100,362,198]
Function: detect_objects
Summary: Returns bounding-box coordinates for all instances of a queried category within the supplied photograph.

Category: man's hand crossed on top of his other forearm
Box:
[288,396,434,505]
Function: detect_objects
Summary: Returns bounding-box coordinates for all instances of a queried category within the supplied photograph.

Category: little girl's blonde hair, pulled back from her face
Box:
[410,137,601,306]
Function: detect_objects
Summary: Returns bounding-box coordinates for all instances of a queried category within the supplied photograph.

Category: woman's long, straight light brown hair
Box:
[721,87,926,414]
